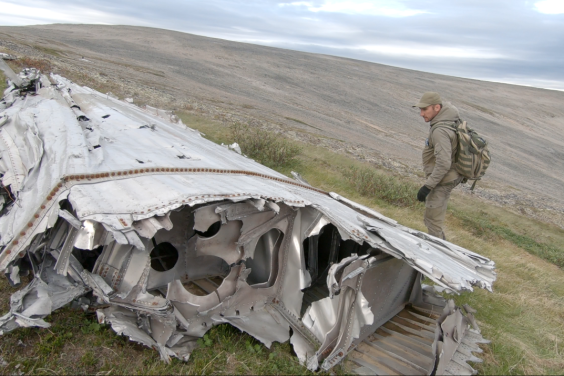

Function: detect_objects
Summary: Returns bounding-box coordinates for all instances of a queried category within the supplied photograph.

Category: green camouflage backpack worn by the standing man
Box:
[438,121,491,191]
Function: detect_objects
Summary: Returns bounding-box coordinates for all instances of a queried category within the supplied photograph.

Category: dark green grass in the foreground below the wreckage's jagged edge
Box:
[0,296,334,375]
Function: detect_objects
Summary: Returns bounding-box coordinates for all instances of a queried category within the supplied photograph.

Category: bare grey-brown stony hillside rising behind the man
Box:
[0,25,564,227]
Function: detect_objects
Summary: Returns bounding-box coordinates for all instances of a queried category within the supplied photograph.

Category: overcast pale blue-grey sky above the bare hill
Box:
[0,0,564,90]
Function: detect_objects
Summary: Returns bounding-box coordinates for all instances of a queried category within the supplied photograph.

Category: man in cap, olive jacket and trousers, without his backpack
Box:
[413,92,463,240]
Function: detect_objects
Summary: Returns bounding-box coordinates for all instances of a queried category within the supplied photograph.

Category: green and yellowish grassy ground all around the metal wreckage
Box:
[0,59,564,374]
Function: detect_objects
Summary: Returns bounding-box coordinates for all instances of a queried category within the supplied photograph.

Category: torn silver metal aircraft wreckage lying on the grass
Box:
[0,60,496,374]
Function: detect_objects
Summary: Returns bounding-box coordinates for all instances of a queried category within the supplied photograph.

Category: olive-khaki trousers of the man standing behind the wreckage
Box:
[423,177,463,240]
